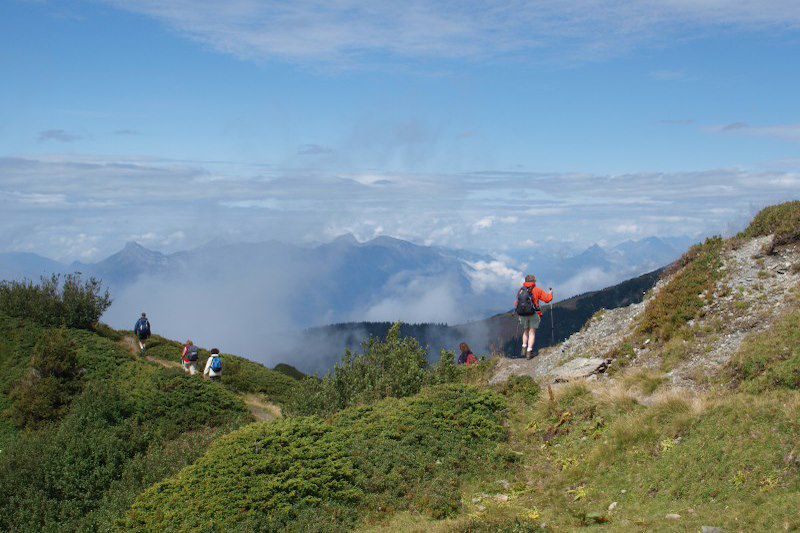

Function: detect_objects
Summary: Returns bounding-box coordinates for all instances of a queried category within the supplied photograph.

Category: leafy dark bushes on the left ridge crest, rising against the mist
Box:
[0,274,111,329]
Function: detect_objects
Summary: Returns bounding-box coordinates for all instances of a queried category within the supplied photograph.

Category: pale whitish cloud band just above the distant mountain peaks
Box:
[0,157,800,262]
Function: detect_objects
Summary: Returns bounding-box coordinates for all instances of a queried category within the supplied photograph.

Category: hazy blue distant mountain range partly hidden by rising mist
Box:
[0,235,690,369]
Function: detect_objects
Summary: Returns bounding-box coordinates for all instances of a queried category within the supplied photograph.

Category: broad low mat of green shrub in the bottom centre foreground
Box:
[124,385,507,531]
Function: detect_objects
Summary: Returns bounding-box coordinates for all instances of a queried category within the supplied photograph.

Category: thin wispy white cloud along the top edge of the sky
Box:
[101,0,800,66]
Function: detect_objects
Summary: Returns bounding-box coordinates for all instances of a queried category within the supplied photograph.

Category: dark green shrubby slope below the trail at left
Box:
[0,315,291,531]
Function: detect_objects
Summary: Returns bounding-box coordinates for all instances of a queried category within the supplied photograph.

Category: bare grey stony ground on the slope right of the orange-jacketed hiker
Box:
[491,237,800,390]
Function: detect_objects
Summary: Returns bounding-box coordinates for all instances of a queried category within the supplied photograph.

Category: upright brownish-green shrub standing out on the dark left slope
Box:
[10,330,80,428]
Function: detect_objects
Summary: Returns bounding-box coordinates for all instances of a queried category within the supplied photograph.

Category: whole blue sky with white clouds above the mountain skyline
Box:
[0,0,800,260]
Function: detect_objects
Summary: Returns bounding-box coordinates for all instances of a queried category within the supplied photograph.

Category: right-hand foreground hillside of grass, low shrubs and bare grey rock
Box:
[117,203,800,532]
